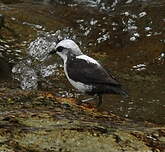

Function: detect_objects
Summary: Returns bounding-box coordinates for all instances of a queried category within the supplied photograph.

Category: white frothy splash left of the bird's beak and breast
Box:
[12,33,57,90]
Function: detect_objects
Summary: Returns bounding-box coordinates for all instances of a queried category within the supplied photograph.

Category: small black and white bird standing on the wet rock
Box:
[49,39,127,107]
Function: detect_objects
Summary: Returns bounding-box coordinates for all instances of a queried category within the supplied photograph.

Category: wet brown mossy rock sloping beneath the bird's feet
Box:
[0,88,165,152]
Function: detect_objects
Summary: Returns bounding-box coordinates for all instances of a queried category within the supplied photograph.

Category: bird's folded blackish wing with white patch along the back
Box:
[66,55,120,86]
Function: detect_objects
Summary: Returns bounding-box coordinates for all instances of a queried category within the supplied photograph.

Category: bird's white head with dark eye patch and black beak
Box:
[50,39,83,61]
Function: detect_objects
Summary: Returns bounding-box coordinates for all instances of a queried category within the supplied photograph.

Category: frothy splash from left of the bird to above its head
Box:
[12,27,81,90]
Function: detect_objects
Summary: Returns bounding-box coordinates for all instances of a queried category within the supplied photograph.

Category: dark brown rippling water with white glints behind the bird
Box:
[0,0,165,123]
